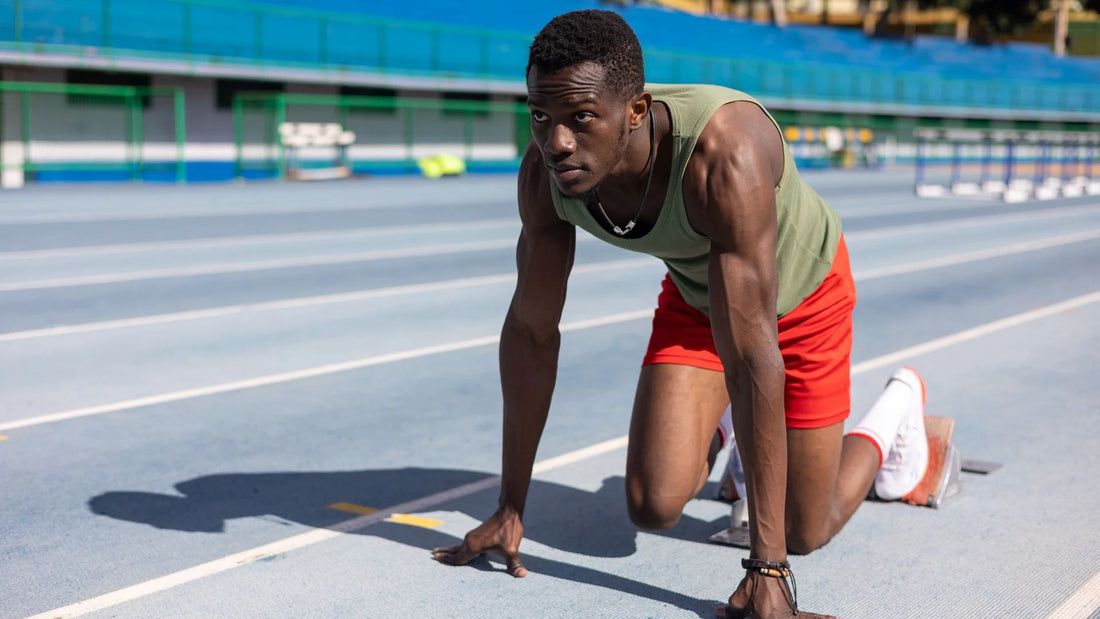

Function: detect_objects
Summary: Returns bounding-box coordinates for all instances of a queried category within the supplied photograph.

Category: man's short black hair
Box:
[527,9,646,99]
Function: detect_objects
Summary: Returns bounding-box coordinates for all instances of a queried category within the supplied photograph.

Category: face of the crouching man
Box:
[527,63,629,197]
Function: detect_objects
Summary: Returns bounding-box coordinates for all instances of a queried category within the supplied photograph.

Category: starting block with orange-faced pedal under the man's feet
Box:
[708,414,1001,549]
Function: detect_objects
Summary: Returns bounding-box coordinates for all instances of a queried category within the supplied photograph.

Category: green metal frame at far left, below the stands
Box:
[0,81,187,183]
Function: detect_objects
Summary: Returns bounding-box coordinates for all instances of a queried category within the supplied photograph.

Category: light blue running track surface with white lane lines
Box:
[0,170,1100,619]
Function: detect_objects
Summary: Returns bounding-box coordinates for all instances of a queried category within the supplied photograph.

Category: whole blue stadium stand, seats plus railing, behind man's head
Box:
[8,0,1100,110]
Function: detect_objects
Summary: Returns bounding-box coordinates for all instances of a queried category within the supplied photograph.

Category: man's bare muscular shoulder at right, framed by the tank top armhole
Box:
[683,101,784,234]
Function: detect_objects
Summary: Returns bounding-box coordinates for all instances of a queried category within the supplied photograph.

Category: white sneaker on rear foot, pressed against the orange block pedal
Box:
[875,367,928,500]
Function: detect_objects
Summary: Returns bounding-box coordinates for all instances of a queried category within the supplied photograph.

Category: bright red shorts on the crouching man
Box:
[642,236,856,428]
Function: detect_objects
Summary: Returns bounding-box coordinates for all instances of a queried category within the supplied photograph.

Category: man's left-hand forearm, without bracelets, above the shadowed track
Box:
[499,311,561,517]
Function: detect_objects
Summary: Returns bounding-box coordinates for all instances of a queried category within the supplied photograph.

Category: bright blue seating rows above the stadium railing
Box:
[251,0,1100,85]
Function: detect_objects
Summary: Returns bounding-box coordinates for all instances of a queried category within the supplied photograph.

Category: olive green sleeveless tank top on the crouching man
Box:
[550,84,840,317]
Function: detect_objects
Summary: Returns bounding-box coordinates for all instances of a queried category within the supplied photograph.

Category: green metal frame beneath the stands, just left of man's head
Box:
[233,92,530,179]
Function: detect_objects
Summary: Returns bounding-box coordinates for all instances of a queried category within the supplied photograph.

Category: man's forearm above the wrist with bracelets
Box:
[727,349,787,561]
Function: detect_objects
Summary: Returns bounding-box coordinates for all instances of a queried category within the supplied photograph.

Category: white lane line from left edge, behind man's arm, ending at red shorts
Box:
[0,309,653,431]
